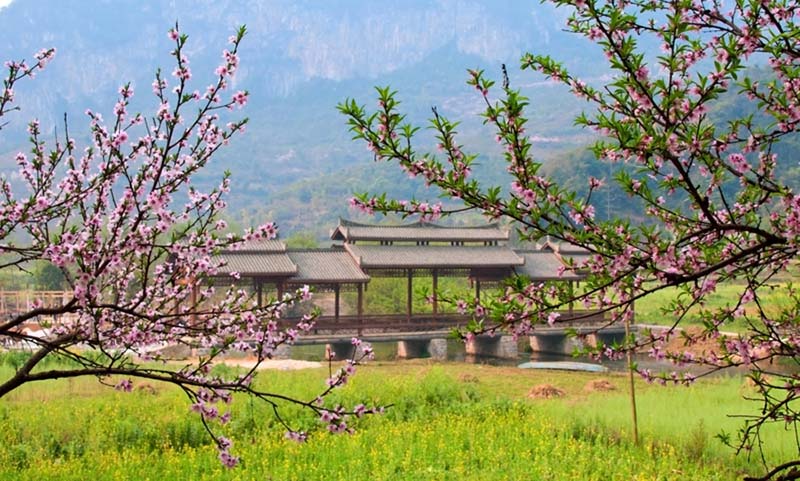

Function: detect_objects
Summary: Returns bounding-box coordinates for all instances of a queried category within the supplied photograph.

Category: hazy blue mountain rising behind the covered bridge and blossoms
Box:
[0,0,605,234]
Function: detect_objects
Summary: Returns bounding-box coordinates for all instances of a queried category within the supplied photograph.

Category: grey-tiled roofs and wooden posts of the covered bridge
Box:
[212,219,586,320]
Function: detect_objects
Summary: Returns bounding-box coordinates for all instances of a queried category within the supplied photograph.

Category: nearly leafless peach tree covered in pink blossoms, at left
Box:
[0,25,372,466]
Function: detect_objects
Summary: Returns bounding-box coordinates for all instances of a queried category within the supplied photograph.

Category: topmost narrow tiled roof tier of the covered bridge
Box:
[331,219,508,242]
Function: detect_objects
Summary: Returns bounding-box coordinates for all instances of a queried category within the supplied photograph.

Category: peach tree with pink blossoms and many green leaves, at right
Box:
[339,0,800,479]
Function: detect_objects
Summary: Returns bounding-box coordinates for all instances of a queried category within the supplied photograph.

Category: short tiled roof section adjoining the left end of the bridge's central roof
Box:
[287,249,369,283]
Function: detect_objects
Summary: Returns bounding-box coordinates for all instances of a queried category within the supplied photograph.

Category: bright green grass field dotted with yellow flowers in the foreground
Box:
[0,361,797,481]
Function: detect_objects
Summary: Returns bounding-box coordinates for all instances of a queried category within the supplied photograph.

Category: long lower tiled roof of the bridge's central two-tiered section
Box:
[345,244,524,269]
